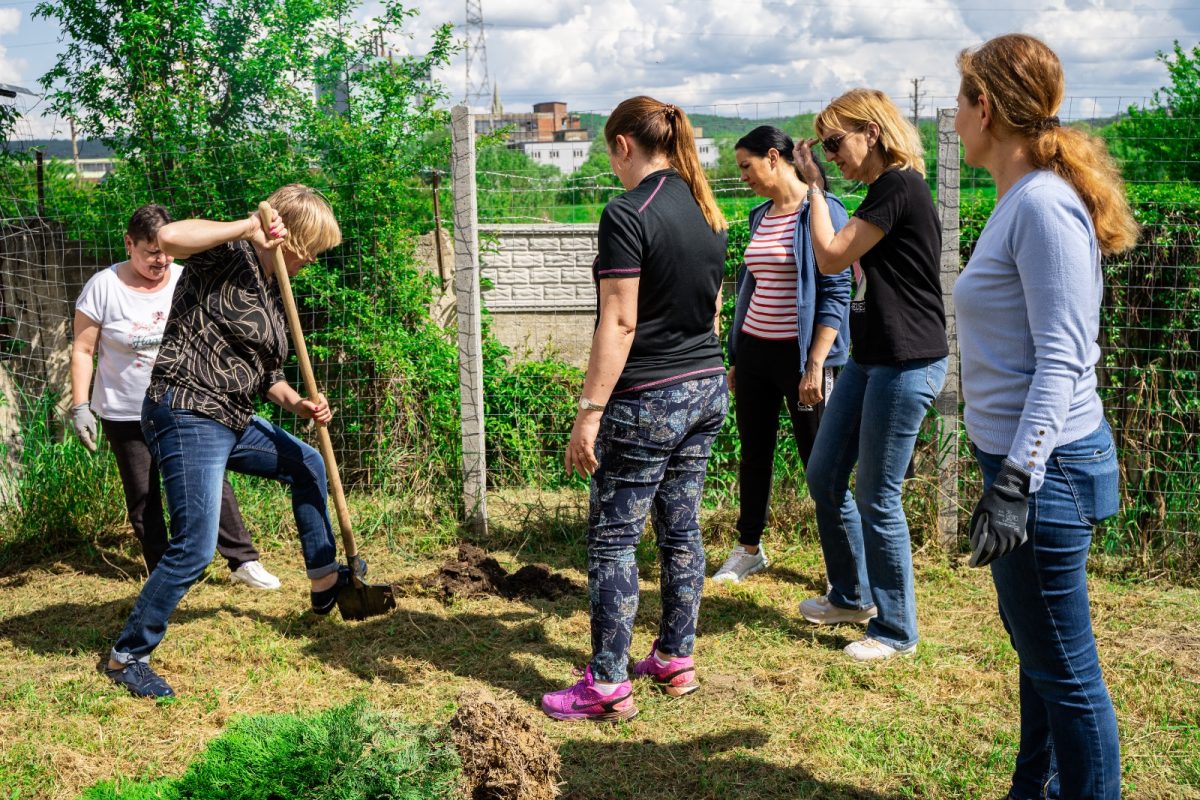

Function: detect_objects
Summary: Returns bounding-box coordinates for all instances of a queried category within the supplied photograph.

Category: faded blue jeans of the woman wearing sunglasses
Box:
[808,359,946,649]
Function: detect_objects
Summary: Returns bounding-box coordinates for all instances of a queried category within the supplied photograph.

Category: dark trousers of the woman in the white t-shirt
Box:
[101,420,258,572]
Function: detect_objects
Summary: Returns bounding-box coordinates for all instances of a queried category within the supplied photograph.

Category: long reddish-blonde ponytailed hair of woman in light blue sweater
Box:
[958,34,1138,255]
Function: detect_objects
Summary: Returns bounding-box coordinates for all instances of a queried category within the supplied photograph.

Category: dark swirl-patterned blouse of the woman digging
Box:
[146,241,288,433]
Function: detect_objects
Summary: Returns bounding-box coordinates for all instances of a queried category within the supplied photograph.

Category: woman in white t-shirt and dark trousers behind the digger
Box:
[71,204,280,589]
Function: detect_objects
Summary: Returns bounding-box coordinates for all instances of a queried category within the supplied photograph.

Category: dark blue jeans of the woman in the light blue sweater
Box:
[976,422,1121,800]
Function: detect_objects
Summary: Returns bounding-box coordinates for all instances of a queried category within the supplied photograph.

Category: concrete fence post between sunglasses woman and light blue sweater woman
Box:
[934,108,962,548]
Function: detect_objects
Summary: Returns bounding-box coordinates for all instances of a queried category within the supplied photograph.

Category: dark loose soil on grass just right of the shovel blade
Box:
[421,543,575,600]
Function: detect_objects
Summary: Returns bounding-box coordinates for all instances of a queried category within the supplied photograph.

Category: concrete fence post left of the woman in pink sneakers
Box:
[450,106,487,534]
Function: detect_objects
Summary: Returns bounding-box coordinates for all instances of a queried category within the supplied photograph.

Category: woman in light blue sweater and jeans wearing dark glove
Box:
[954,35,1136,800]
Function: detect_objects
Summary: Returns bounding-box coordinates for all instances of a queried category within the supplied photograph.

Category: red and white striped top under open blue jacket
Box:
[742,211,799,339]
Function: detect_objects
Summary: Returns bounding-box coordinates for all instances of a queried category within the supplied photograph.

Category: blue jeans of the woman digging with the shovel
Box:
[112,392,337,663]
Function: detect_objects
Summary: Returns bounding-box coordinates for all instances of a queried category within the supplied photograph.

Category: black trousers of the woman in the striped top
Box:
[733,333,836,546]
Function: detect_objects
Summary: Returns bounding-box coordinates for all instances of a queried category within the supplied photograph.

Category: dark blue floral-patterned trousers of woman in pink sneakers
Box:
[588,375,730,684]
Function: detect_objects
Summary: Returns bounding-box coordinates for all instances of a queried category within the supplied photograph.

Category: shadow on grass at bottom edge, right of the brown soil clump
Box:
[558,728,900,800]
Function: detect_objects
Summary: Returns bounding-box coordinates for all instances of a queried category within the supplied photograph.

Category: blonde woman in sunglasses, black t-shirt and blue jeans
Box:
[796,89,949,661]
